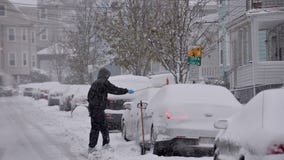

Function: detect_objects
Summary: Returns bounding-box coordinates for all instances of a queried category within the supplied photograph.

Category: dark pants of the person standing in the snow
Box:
[89,111,109,148]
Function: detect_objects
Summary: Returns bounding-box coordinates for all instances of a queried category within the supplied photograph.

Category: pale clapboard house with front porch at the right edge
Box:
[224,0,284,103]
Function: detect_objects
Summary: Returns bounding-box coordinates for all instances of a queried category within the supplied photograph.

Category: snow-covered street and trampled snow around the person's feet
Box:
[0,96,212,160]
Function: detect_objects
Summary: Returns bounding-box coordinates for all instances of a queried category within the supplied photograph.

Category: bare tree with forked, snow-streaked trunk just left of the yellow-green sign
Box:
[150,0,216,83]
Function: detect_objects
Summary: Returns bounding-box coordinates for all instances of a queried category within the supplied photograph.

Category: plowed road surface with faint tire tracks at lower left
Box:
[0,97,77,160]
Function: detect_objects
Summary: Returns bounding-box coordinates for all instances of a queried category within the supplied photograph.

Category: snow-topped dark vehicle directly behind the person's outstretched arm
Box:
[105,75,152,131]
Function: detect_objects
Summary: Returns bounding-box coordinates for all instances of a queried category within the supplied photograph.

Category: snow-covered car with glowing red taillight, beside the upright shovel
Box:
[139,84,242,157]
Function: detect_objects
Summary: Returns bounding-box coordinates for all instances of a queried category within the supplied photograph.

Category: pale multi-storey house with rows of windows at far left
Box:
[0,0,36,83]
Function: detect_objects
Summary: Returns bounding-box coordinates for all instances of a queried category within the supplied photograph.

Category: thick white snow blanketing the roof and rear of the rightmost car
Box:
[220,88,284,153]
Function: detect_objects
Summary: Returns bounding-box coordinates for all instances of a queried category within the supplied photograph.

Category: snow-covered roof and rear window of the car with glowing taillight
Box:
[151,84,241,107]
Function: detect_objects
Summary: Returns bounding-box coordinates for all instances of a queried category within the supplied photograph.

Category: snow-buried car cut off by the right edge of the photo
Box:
[214,88,284,160]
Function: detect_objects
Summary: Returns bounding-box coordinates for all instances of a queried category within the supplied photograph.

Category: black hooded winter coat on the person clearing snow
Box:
[88,68,128,117]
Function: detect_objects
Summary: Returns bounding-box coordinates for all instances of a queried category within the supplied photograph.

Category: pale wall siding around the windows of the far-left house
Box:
[0,0,36,83]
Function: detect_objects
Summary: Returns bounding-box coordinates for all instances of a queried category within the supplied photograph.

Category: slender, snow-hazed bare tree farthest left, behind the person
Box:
[66,0,104,83]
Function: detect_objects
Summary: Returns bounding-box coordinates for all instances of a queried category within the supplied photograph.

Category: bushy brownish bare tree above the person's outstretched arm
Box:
[97,0,153,75]
